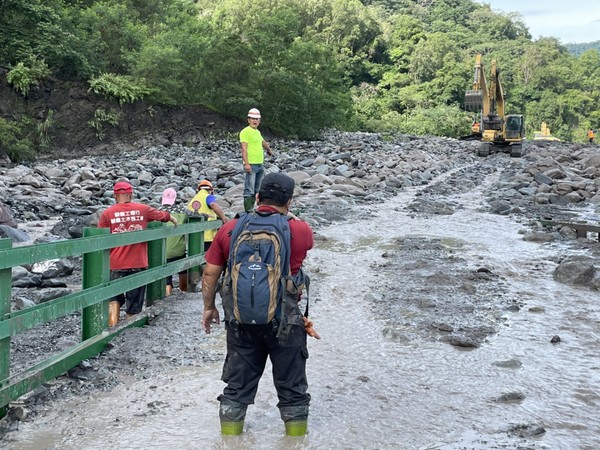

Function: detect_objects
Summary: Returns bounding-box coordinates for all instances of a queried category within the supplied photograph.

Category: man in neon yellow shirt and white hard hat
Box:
[240,108,273,211]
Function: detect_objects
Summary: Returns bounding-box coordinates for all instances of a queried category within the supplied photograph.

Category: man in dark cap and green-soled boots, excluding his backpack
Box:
[202,173,314,436]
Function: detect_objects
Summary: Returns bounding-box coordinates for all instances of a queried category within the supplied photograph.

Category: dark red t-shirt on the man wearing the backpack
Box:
[205,205,315,275]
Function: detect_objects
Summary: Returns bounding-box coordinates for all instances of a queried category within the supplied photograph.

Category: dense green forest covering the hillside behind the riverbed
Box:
[0,0,600,160]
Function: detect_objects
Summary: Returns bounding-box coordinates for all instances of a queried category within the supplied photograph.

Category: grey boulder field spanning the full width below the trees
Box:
[0,131,600,302]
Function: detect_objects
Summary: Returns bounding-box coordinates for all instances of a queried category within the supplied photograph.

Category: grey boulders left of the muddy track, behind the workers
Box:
[0,132,474,237]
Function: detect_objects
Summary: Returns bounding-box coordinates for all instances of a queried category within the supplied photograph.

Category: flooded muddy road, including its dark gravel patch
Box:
[0,155,600,450]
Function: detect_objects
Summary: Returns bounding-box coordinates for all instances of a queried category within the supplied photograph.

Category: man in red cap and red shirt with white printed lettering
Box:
[98,181,177,326]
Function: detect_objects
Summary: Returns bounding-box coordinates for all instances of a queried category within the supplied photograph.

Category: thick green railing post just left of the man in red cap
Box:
[81,228,110,341]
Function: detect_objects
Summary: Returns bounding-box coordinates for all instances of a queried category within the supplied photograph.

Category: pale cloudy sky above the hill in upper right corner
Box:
[479,0,600,44]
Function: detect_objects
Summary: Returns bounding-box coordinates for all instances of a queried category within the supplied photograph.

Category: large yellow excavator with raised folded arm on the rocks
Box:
[465,54,525,157]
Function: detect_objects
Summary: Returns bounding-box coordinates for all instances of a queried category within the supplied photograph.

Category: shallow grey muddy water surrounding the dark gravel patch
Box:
[9,166,600,450]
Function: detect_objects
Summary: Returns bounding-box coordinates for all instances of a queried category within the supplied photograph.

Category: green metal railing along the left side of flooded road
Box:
[0,217,222,417]
